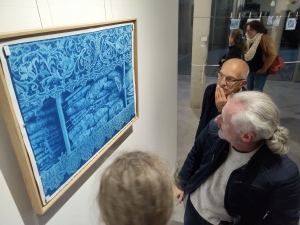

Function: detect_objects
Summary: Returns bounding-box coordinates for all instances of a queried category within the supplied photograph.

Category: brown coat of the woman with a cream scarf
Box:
[260,34,278,72]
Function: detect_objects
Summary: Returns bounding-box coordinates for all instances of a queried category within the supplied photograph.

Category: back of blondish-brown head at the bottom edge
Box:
[98,151,174,225]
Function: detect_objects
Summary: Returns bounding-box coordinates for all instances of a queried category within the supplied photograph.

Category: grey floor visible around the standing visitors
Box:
[171,75,300,225]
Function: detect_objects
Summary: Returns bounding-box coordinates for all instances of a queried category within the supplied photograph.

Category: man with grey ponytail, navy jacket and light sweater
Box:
[174,91,300,225]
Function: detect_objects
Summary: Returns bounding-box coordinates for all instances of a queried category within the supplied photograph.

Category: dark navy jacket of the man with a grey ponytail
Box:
[179,120,300,225]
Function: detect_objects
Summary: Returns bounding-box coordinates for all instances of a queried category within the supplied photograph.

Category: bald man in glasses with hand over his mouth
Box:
[195,58,249,139]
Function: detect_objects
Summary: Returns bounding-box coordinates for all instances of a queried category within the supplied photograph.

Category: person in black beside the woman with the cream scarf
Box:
[219,29,245,68]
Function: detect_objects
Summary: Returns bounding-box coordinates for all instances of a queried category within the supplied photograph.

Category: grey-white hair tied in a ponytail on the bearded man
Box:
[230,91,289,155]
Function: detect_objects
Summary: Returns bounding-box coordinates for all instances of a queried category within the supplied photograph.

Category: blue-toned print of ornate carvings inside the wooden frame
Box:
[6,25,135,196]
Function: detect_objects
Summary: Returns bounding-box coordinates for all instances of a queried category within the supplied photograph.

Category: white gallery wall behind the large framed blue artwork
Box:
[0,0,178,225]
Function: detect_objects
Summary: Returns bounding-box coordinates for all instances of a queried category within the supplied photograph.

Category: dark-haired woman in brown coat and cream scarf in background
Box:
[244,20,277,91]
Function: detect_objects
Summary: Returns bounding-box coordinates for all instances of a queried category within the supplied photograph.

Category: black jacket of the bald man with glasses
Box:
[195,84,246,139]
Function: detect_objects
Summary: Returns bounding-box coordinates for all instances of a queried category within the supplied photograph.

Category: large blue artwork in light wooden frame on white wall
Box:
[0,19,138,214]
